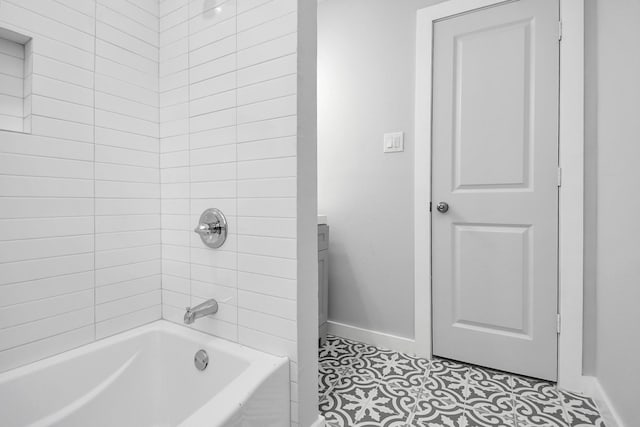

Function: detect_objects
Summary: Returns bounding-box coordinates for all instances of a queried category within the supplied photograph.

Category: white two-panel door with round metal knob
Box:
[432,0,559,380]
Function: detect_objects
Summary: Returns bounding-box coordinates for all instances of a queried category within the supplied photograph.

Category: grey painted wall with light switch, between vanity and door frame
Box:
[318,0,437,338]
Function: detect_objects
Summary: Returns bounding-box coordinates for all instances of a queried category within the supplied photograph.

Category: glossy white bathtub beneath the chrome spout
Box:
[0,321,289,427]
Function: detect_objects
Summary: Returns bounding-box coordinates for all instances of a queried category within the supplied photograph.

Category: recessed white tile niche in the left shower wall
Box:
[0,27,33,133]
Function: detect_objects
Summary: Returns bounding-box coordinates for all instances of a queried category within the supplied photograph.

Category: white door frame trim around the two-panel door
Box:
[414,0,587,391]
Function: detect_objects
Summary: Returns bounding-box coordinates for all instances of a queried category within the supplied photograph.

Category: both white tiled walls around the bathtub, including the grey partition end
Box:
[0,0,317,425]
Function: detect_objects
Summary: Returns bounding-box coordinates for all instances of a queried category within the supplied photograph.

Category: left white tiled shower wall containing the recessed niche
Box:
[0,0,161,371]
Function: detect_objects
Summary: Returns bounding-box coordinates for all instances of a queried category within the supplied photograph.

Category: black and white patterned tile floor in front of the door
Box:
[319,336,604,427]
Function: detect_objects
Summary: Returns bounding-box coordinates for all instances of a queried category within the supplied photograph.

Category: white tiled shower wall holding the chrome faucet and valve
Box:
[160,0,298,422]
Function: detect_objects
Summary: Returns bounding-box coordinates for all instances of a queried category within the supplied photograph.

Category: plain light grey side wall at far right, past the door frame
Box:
[586,0,640,426]
